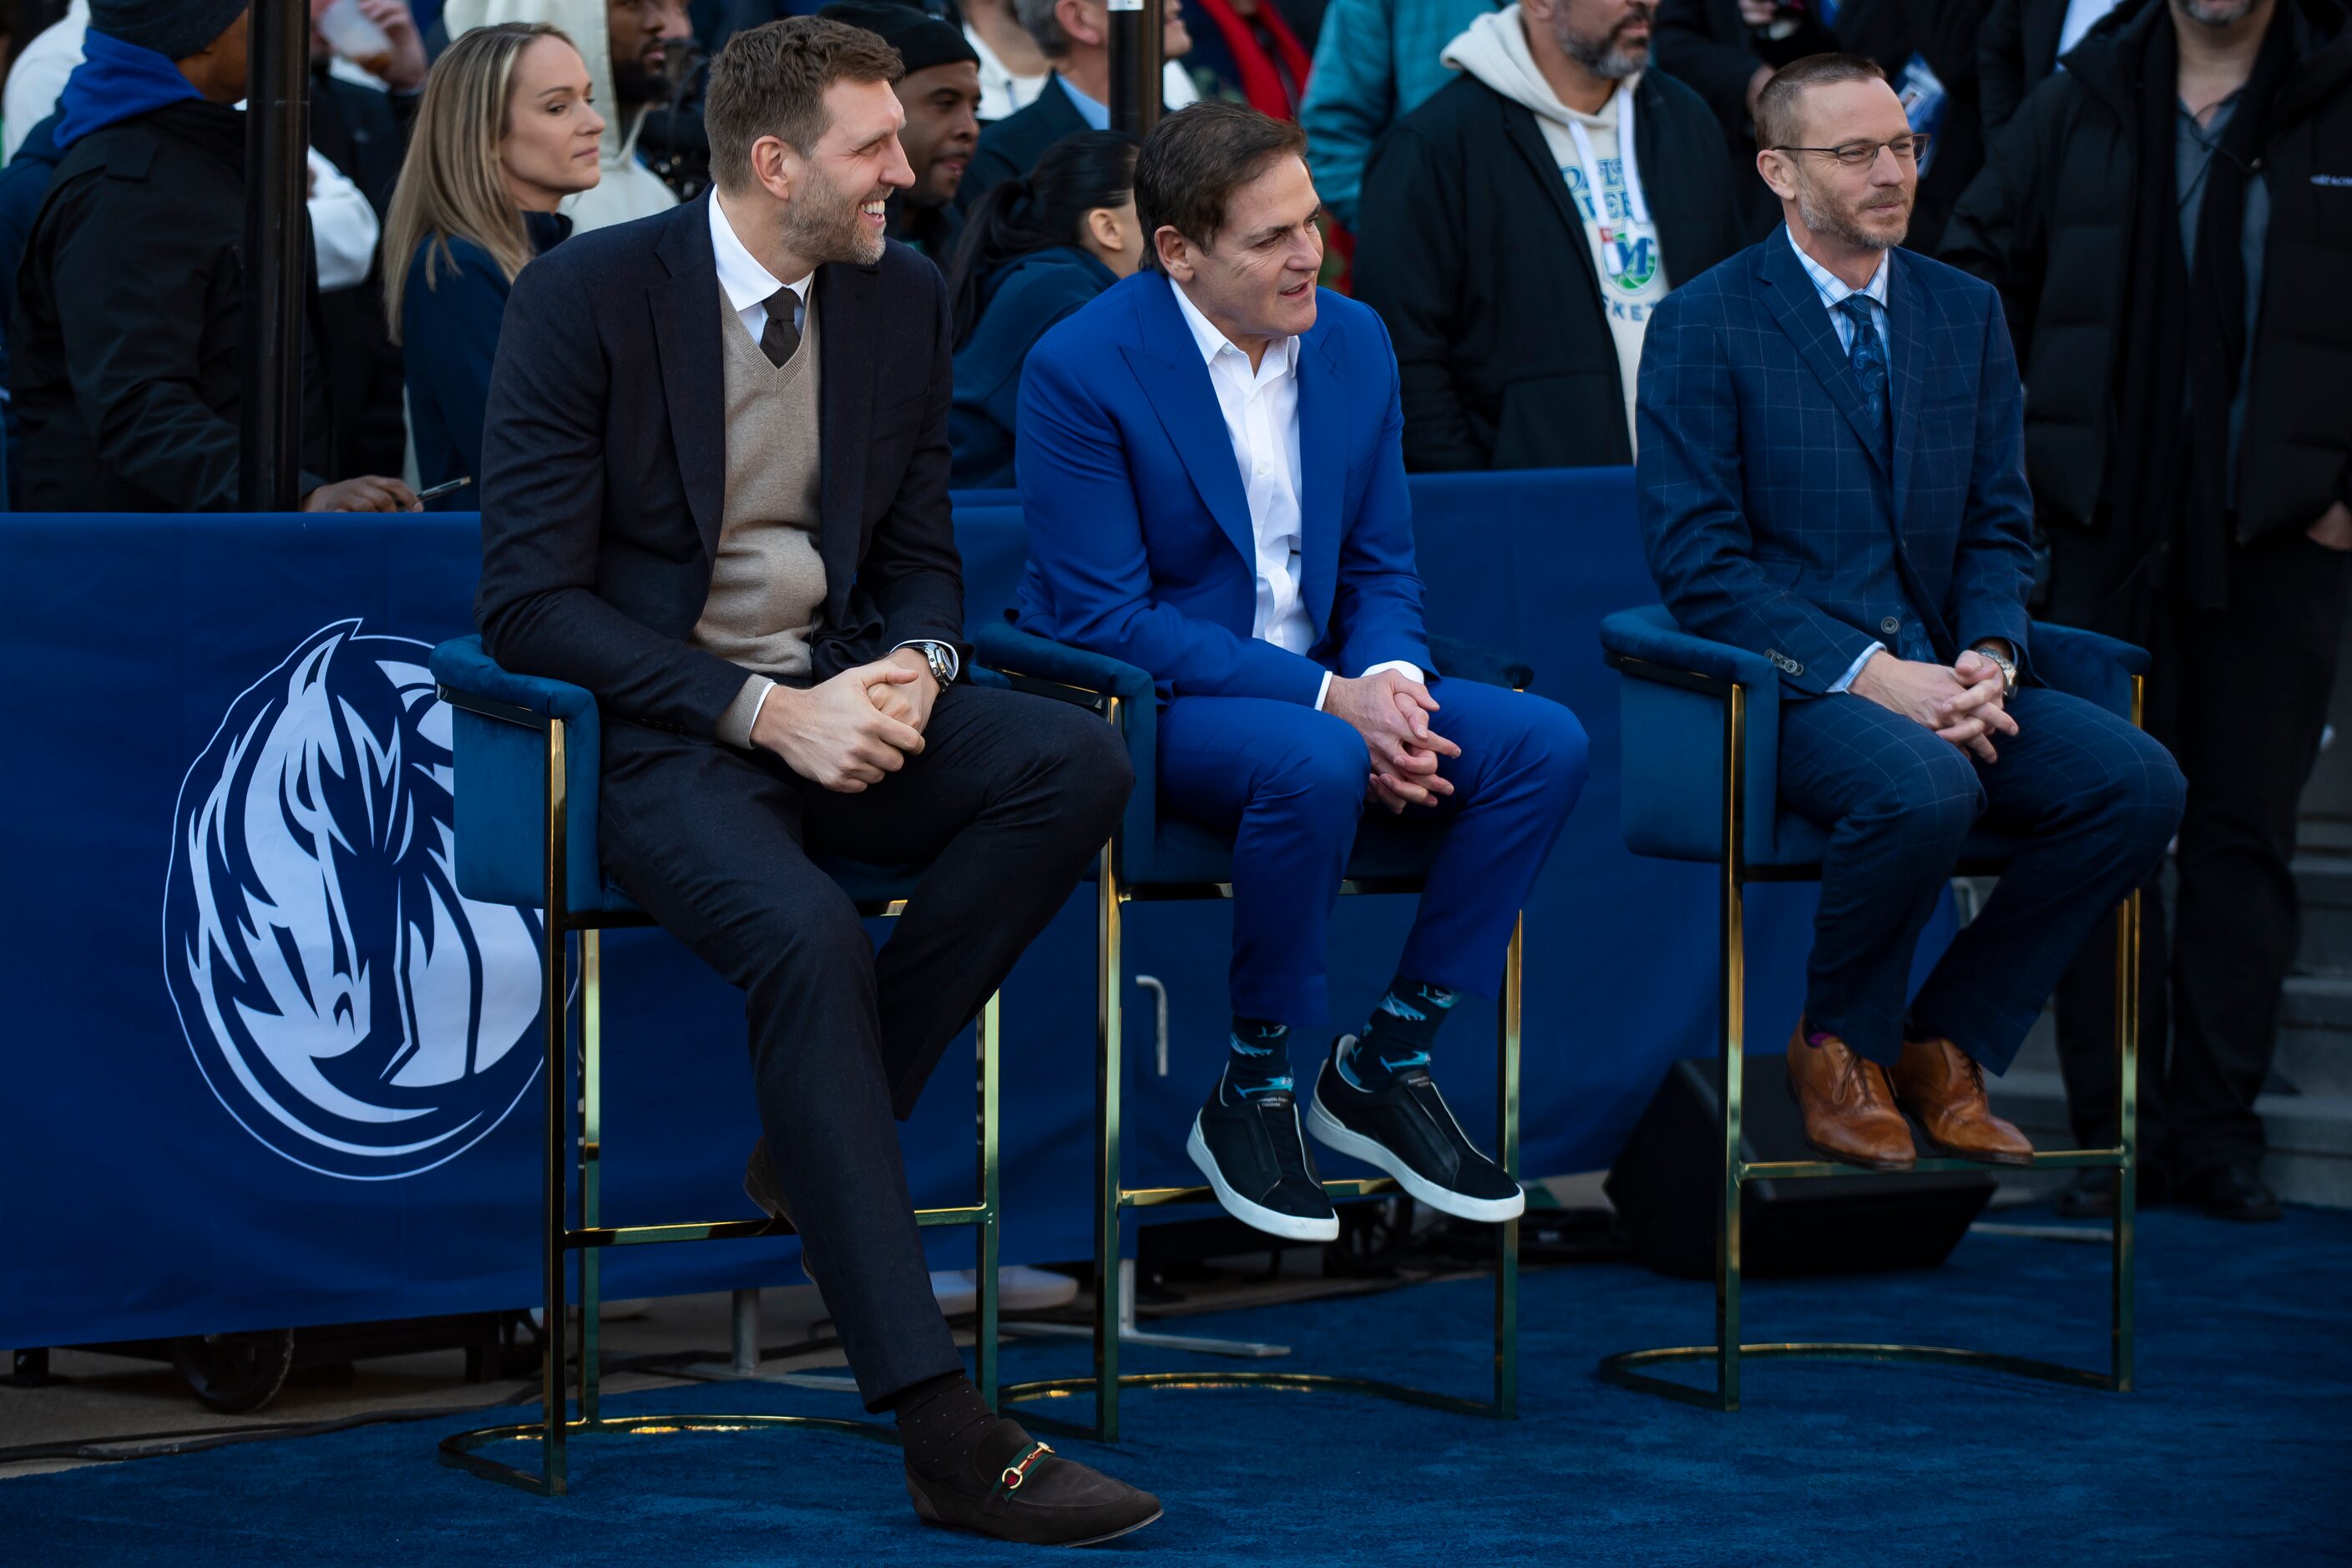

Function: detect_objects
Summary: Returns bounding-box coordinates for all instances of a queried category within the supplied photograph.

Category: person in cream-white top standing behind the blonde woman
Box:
[443,0,694,235]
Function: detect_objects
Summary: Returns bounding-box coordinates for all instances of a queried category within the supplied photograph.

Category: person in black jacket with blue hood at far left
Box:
[9,0,417,513]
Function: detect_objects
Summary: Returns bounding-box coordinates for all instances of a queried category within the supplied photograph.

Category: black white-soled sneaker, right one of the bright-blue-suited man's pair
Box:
[1308,1034,1526,1220]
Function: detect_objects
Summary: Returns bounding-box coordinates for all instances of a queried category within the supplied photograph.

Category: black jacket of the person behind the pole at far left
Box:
[9,101,329,513]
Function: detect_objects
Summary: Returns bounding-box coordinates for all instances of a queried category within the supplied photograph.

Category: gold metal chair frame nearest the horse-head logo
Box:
[440,686,999,1498]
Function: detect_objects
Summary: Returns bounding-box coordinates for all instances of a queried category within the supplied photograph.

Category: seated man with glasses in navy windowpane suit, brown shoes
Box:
[1637,54,2183,1168]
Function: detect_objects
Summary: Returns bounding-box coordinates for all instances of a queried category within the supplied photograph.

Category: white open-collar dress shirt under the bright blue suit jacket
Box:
[1169,280,1423,707]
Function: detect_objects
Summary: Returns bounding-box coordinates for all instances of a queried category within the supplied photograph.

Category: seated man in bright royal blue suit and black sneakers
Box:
[1019,104,1586,1242]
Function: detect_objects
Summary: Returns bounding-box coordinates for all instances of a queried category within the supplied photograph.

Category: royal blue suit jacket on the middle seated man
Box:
[1016,273,1434,706]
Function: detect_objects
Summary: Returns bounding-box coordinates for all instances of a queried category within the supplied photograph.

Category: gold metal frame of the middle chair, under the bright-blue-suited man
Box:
[1002,677,1524,1444]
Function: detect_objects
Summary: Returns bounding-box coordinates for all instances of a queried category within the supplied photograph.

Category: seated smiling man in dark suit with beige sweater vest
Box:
[478,19,1160,1542]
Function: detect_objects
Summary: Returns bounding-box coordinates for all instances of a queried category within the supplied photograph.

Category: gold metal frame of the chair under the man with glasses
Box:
[1600,654,2142,1410]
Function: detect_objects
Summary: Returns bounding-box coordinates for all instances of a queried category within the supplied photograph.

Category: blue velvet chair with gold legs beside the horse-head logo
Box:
[431,637,997,1495]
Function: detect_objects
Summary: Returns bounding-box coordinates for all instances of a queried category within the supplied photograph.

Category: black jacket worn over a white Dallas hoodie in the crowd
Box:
[1355,70,1741,470]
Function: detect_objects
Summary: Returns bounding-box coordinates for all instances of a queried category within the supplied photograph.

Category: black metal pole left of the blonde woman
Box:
[238,0,311,513]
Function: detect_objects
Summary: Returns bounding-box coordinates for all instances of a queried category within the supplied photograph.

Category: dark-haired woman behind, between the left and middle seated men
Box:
[948,132,1143,489]
